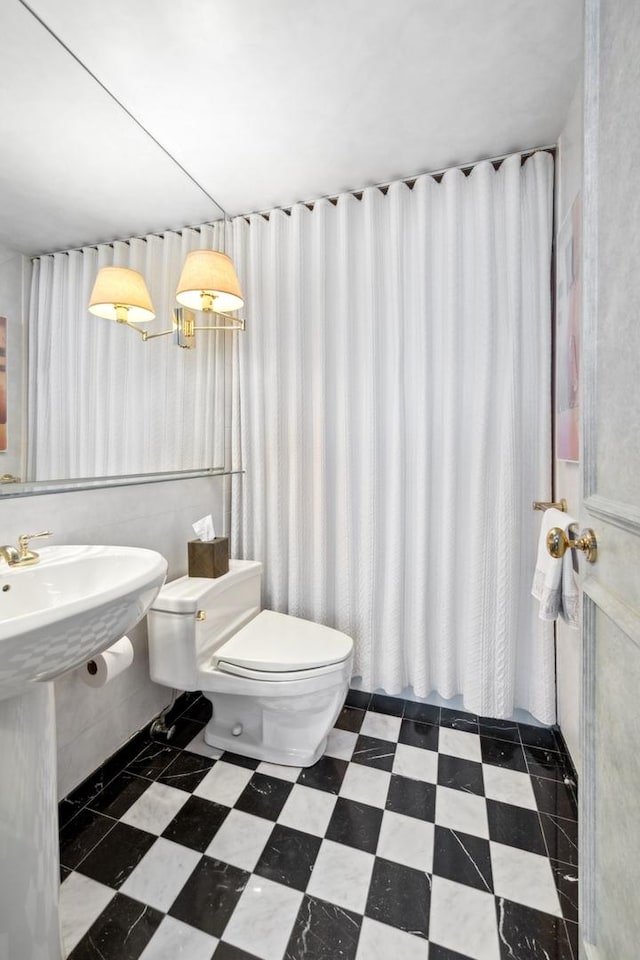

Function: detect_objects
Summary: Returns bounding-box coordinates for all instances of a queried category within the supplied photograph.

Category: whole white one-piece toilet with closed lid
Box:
[147,560,353,767]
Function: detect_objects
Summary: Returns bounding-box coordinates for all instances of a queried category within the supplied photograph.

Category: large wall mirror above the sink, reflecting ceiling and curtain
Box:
[0,0,233,496]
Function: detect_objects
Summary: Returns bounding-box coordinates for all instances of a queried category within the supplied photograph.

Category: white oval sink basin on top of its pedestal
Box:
[0,546,167,700]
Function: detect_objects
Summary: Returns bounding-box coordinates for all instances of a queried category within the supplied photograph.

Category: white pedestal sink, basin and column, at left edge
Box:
[0,546,167,960]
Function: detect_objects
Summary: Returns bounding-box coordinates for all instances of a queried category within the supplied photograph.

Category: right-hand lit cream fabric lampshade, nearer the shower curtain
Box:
[176,250,244,313]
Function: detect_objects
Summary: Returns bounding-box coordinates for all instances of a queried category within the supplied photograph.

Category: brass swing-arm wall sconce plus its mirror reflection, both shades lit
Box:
[89,250,244,349]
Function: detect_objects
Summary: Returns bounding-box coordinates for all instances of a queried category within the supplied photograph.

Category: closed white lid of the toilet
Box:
[216,610,353,672]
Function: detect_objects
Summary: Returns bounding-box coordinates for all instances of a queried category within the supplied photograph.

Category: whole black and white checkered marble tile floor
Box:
[60,692,578,960]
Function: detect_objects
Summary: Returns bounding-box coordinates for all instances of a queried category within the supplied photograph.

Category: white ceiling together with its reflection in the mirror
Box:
[0,0,582,254]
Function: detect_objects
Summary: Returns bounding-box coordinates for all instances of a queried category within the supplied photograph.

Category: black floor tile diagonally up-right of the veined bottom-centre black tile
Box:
[365,857,431,940]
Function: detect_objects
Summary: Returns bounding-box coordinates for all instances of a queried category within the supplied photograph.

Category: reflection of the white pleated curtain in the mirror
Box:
[28,223,226,480]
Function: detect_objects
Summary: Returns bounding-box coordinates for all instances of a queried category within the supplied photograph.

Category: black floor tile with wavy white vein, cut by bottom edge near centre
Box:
[284,896,362,960]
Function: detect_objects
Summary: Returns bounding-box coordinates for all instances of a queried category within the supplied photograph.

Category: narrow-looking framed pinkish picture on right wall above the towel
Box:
[556,194,582,461]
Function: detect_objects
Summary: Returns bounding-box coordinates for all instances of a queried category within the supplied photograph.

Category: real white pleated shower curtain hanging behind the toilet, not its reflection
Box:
[232,153,555,722]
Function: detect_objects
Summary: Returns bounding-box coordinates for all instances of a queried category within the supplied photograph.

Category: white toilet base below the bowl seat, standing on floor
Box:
[202,680,349,767]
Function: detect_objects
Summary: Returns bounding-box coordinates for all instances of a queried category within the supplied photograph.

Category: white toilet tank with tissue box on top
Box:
[147,560,262,690]
